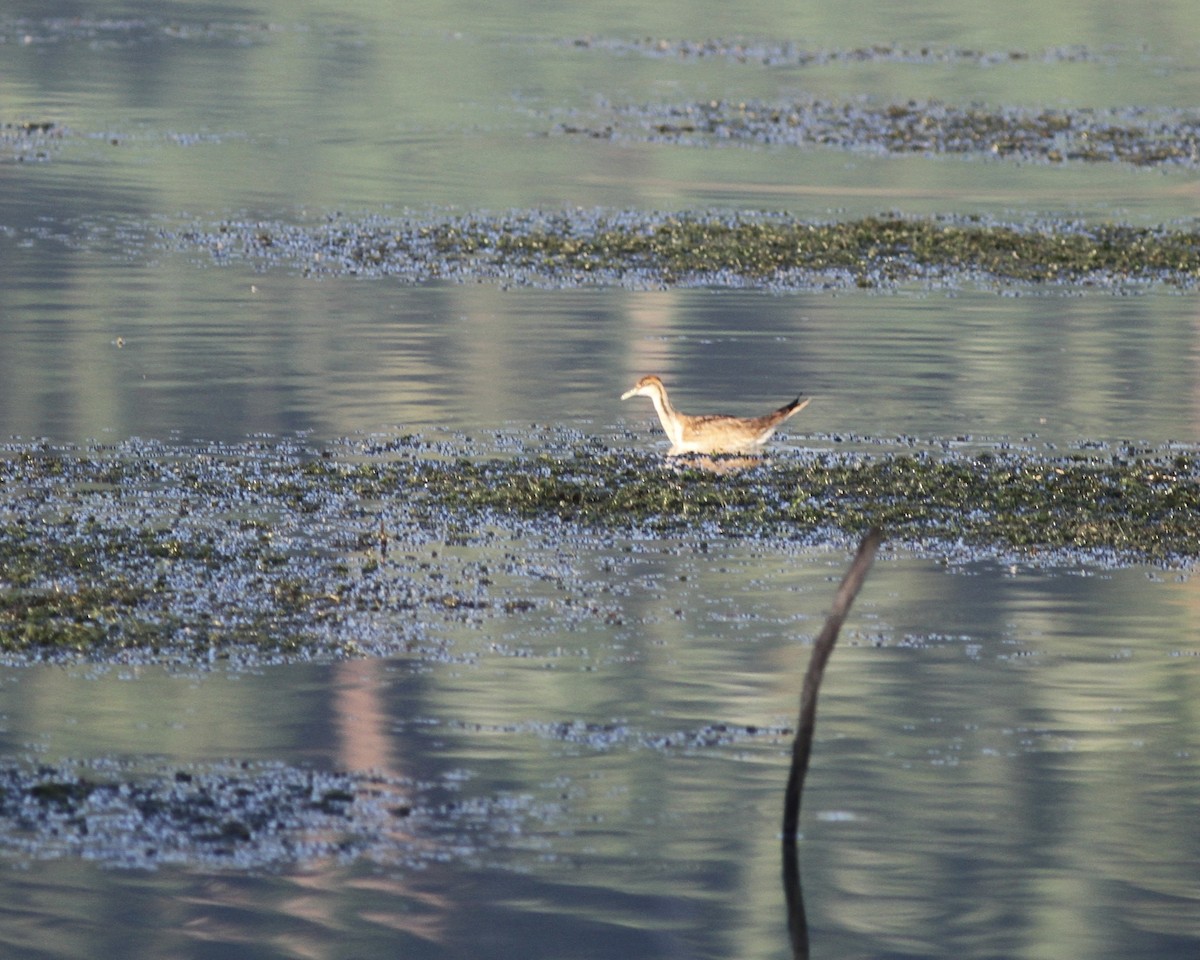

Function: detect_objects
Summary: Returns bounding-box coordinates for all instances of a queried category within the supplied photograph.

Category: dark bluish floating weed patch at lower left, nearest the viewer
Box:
[0,758,562,870]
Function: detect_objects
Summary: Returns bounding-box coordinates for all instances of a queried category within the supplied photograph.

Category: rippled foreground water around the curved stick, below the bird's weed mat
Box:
[0,552,1200,956]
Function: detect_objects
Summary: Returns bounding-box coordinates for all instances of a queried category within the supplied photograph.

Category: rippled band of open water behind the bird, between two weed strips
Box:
[0,267,1200,448]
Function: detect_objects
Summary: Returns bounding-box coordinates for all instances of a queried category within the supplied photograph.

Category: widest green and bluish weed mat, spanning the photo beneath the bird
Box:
[0,437,1200,664]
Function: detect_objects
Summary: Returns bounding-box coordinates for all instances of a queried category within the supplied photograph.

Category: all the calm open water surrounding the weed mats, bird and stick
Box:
[0,2,1200,958]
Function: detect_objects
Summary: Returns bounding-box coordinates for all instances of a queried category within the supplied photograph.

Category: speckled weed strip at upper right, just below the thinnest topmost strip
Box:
[558,100,1200,168]
